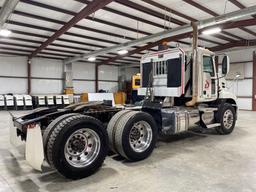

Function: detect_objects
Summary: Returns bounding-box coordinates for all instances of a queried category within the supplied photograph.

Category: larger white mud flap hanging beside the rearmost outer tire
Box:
[25,125,44,171]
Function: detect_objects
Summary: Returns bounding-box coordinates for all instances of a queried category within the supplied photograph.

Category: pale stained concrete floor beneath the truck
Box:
[0,111,256,192]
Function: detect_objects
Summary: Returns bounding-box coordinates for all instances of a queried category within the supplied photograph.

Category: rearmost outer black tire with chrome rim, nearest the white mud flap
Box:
[47,115,108,179]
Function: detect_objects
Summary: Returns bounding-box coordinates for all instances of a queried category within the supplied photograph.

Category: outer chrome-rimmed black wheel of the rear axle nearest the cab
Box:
[114,111,158,161]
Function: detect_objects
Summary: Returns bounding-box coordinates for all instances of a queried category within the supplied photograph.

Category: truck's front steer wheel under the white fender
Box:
[216,103,236,135]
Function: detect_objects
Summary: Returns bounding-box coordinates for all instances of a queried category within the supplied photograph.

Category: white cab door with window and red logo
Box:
[202,54,217,100]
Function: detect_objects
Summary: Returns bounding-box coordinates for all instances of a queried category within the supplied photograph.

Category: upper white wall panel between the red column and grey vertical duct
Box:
[31,58,63,78]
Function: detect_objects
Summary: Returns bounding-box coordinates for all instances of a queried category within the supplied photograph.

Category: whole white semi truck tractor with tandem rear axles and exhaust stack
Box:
[11,29,238,179]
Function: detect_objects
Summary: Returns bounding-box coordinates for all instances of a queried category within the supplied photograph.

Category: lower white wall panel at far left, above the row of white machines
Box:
[0,78,27,94]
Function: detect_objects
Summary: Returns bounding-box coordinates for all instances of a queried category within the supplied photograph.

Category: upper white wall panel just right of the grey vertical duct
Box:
[72,62,95,79]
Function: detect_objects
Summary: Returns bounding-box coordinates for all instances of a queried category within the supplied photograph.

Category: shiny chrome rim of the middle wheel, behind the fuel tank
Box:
[129,121,152,153]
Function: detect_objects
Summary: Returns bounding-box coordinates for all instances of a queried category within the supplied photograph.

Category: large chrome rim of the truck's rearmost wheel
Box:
[64,128,100,168]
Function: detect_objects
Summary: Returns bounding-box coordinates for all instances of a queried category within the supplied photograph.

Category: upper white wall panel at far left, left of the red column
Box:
[0,57,27,77]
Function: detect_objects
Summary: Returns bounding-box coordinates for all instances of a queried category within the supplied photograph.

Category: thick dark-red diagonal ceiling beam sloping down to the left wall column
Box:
[30,0,113,57]
